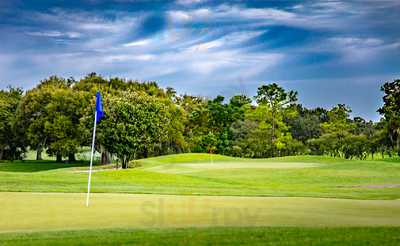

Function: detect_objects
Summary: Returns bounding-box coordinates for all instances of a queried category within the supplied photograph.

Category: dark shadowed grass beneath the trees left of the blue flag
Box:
[0,160,89,173]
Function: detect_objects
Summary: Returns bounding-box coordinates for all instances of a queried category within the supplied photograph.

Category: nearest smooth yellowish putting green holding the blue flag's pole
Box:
[0,192,400,232]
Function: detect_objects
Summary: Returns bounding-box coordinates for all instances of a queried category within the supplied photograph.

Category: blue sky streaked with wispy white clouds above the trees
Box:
[0,0,400,120]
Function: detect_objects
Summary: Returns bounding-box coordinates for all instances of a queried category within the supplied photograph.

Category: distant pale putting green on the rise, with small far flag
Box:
[146,161,323,174]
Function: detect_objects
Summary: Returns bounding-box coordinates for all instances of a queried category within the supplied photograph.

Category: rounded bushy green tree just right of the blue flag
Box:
[98,91,170,168]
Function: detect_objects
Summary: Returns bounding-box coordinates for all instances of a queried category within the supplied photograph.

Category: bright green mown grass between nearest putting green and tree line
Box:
[0,154,400,199]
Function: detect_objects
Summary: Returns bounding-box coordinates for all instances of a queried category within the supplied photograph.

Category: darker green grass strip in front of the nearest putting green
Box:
[0,227,400,246]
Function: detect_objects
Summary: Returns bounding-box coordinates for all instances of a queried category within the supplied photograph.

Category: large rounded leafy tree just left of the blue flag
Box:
[17,76,89,162]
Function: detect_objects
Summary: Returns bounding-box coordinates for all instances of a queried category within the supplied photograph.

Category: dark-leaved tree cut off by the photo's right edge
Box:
[378,79,400,156]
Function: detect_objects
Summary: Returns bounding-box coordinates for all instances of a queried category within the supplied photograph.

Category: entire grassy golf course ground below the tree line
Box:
[0,153,400,245]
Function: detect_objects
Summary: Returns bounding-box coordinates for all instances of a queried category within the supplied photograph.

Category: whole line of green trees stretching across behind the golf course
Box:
[0,73,400,168]
